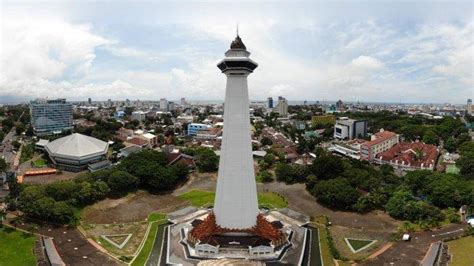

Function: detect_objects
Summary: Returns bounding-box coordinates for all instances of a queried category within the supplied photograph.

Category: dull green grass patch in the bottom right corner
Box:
[447,236,474,266]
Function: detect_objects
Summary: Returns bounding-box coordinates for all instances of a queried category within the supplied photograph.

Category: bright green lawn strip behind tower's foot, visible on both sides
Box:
[178,190,288,208]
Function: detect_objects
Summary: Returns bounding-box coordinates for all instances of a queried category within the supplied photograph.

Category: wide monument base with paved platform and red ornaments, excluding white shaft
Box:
[163,208,309,264]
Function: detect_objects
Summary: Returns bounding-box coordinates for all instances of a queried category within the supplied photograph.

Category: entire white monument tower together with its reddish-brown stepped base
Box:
[167,33,310,265]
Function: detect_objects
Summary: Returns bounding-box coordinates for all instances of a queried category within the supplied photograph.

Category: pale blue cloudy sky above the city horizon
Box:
[0,0,474,104]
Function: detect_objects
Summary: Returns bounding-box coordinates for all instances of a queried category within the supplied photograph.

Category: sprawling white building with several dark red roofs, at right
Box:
[374,142,439,170]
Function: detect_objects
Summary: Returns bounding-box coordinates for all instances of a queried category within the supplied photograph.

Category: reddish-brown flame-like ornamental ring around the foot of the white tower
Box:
[188,213,286,246]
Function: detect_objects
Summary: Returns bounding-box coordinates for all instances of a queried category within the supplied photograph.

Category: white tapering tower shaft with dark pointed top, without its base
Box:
[214,33,259,229]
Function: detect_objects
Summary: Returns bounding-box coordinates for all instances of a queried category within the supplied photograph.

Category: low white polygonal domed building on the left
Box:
[45,133,109,172]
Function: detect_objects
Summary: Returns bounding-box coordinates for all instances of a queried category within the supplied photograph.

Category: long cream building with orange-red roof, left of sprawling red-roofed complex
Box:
[360,129,399,161]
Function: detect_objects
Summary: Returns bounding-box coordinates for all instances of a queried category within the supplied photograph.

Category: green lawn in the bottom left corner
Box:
[0,226,36,266]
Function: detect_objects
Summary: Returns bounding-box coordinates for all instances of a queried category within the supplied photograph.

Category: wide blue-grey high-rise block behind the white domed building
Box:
[30,99,73,136]
